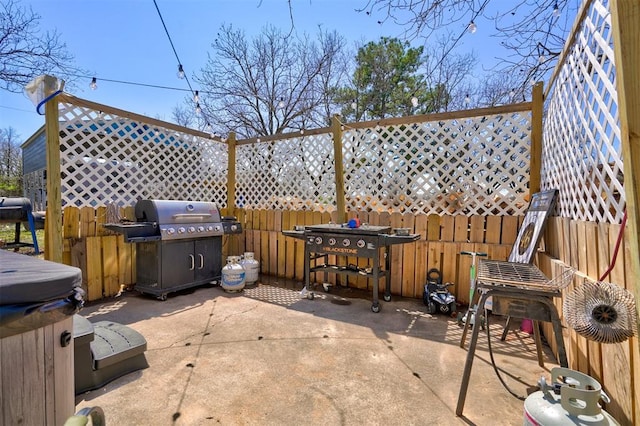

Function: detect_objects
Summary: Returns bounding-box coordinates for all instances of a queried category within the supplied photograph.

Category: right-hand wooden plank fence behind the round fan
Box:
[537,217,640,424]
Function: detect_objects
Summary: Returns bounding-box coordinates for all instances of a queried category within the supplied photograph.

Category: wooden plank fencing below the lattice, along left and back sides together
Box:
[63,207,522,303]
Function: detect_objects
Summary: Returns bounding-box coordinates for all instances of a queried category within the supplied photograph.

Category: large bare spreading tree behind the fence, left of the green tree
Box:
[196,25,345,137]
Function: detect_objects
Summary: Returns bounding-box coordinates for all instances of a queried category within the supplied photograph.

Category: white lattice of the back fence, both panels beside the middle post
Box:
[236,112,531,215]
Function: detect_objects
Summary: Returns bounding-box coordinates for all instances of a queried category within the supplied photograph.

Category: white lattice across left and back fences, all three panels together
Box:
[60,102,531,215]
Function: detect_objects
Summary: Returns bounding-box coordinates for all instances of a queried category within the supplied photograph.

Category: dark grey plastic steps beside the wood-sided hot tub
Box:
[73,315,149,395]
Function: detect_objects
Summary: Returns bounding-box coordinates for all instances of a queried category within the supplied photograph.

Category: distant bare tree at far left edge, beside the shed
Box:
[0,127,22,197]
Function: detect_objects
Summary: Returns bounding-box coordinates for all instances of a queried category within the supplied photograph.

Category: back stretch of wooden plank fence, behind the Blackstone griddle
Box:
[184,210,522,303]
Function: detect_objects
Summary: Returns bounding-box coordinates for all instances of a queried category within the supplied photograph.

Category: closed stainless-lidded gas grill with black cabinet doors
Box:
[104,200,242,300]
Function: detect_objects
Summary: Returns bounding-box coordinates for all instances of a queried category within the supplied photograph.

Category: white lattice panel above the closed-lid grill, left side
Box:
[60,103,228,207]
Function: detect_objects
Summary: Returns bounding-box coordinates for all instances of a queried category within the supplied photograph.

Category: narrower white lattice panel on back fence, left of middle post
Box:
[236,134,336,211]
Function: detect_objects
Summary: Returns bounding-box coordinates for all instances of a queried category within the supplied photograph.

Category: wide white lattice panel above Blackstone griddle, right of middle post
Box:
[343,112,531,215]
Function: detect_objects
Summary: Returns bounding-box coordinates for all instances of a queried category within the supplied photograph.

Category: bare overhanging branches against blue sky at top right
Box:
[357,0,581,93]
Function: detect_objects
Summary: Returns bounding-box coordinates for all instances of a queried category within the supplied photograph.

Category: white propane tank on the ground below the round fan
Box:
[524,367,619,426]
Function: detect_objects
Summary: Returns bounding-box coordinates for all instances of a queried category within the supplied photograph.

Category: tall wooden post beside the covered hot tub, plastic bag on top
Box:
[44,86,63,263]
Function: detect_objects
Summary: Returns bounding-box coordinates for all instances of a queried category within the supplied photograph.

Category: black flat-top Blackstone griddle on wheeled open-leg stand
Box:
[282,224,420,312]
